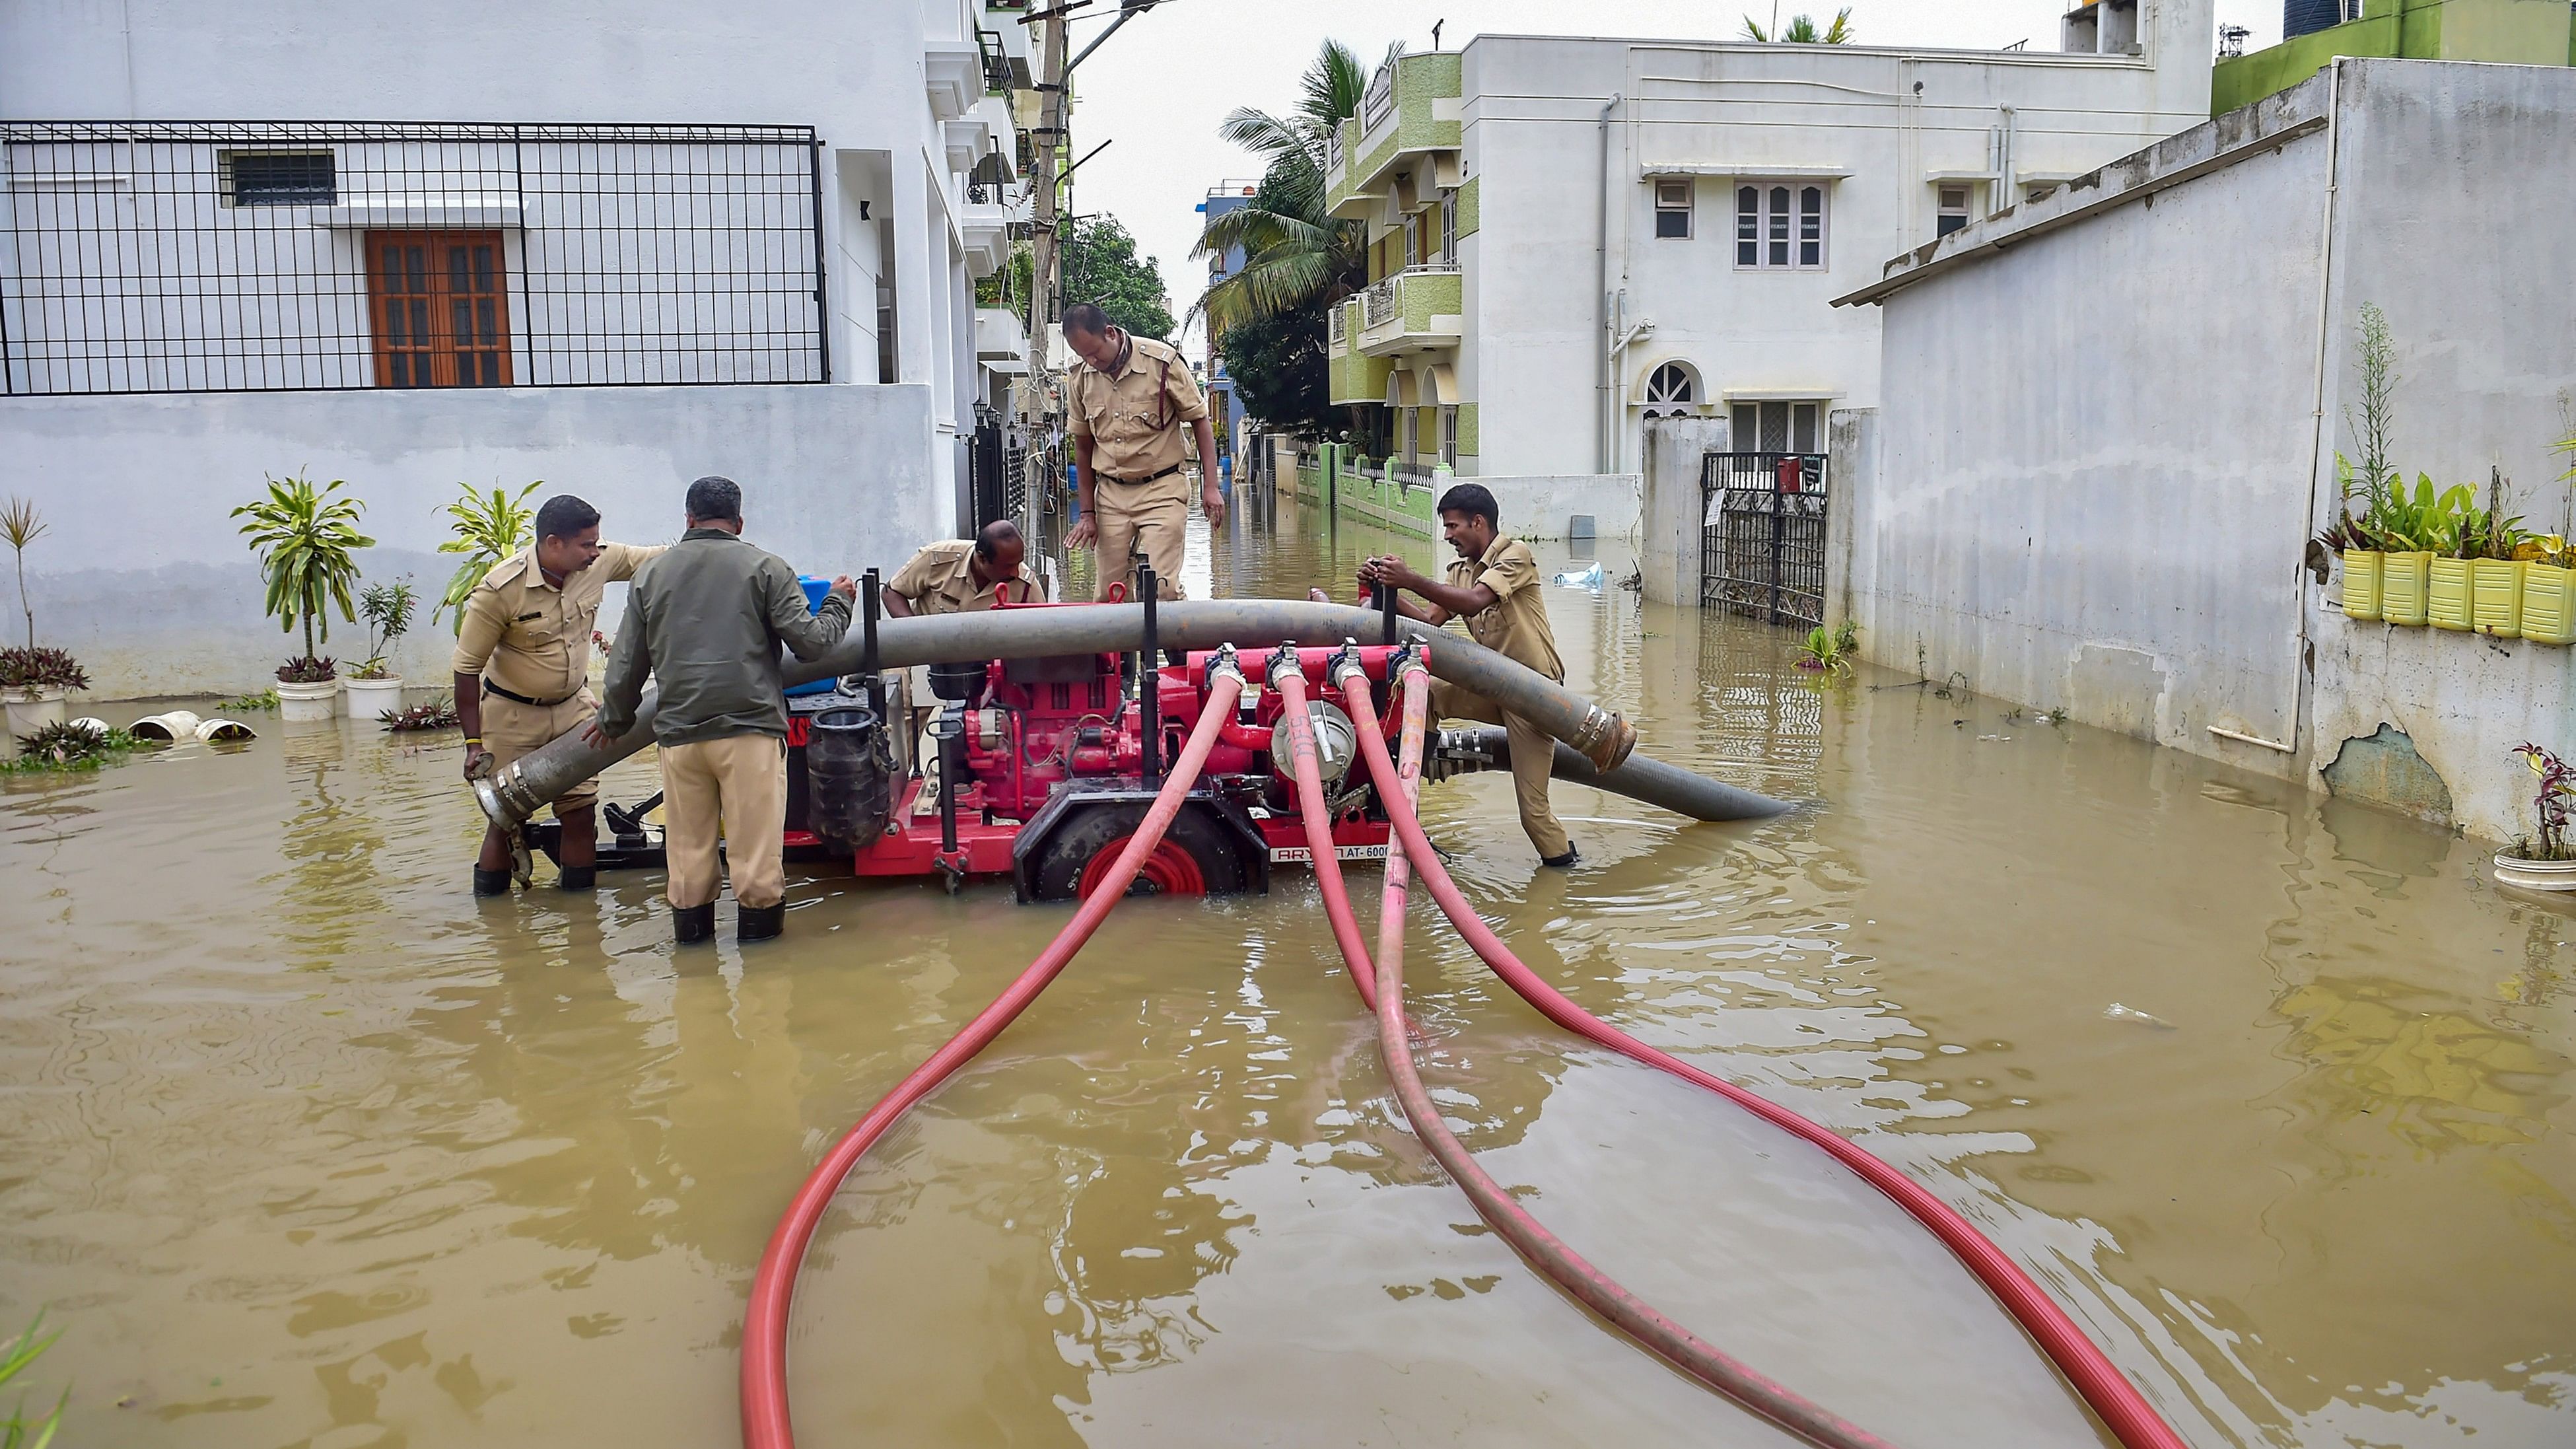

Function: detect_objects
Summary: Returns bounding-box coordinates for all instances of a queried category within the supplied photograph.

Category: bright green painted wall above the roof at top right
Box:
[2210,0,2576,116]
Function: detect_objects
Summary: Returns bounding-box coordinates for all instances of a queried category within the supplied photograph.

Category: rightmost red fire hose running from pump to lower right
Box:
[1316,684,2187,1449]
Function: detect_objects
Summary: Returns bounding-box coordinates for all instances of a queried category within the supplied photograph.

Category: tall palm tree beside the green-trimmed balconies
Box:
[1190,41,1404,337]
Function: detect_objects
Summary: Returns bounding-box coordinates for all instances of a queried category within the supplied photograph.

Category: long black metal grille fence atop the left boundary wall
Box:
[0,121,832,394]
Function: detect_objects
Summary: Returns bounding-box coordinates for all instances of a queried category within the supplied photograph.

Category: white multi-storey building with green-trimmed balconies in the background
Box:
[1329,0,2215,512]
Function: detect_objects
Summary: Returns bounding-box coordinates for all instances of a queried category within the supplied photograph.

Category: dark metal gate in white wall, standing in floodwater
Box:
[1700,454,1829,629]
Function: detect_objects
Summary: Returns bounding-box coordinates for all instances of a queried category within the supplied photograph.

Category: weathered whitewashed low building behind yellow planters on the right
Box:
[1827,59,2576,838]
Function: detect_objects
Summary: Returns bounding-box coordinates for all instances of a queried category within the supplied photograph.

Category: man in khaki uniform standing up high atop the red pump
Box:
[1064,302,1226,598]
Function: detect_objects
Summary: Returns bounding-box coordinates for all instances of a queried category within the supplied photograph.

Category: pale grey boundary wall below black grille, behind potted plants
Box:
[0,384,948,699]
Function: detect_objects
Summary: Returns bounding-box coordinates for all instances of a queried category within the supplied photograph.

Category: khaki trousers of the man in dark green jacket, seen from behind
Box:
[662,732,788,910]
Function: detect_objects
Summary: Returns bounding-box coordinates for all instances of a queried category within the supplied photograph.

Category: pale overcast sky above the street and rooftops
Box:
[1072,0,2280,348]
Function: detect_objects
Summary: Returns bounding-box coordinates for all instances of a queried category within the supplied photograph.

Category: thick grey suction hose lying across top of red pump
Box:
[474,598,1785,828]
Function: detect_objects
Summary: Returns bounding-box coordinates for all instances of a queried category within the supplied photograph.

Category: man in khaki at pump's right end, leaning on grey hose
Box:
[1360,482,1582,869]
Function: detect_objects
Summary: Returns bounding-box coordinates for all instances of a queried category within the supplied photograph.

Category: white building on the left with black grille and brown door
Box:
[0,0,1030,693]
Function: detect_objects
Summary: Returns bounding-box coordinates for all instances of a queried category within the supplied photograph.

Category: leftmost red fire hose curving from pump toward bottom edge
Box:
[742,657,1244,1449]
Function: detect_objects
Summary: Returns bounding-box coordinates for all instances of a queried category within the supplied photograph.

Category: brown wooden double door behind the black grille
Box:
[366,232,510,387]
